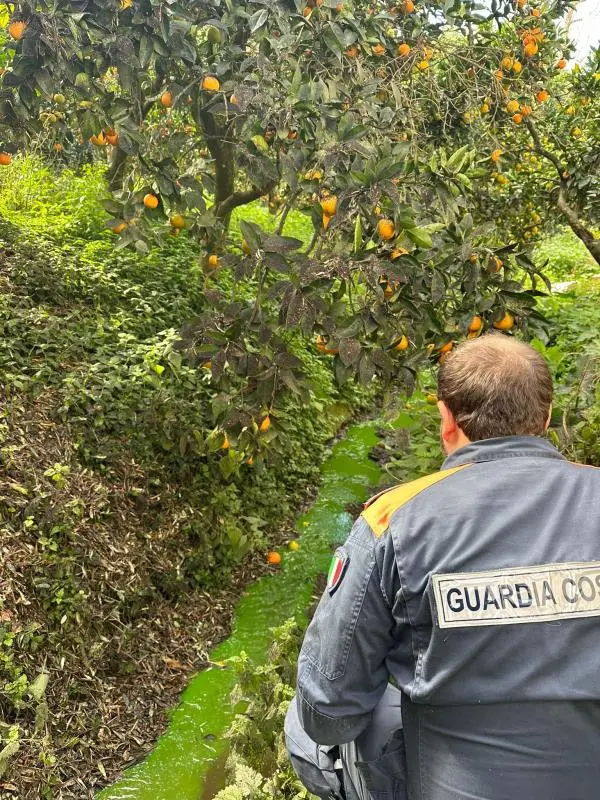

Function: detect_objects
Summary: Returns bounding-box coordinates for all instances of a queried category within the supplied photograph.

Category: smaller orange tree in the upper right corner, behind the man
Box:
[418,2,600,263]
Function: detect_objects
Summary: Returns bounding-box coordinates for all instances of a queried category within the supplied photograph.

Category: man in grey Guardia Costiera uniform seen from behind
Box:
[290,334,600,800]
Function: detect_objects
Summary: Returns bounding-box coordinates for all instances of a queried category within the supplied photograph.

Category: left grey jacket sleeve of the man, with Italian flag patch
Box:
[297,517,395,745]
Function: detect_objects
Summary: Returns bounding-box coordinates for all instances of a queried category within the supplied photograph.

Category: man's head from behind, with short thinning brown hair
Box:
[438,334,552,454]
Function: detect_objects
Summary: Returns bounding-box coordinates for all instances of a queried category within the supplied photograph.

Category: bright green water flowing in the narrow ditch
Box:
[97,424,381,800]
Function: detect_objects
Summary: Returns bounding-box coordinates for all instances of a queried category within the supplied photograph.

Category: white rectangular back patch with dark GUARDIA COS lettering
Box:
[432,561,600,628]
